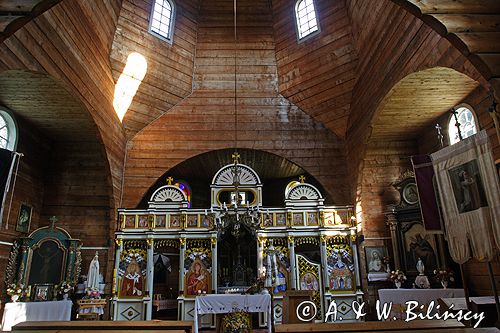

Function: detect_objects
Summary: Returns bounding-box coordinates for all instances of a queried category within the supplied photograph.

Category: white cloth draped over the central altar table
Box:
[194,294,272,333]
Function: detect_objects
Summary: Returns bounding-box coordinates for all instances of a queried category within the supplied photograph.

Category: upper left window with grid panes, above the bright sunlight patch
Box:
[149,0,175,44]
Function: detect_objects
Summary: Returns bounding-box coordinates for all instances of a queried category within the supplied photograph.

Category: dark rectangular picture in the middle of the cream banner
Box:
[448,160,488,213]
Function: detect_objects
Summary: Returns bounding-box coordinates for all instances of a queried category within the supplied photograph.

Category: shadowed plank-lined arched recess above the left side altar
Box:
[0,70,115,244]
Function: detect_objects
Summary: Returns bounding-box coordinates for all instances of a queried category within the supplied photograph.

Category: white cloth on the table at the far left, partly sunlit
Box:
[2,300,73,331]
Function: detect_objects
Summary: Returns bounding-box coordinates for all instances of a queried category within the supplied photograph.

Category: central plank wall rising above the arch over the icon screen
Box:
[123,0,350,207]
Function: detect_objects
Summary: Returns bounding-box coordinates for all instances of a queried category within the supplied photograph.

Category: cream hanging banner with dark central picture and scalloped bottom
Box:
[431,131,500,264]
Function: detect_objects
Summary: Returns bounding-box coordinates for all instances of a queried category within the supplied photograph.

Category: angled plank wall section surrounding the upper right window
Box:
[272,0,358,138]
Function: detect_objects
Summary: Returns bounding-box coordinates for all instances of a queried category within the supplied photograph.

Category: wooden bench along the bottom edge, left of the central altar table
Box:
[12,320,193,333]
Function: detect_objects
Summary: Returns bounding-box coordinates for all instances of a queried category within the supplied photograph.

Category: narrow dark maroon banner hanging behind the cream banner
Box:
[411,155,442,233]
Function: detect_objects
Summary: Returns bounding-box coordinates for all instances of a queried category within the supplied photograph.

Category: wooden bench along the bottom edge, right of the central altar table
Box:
[275,320,465,333]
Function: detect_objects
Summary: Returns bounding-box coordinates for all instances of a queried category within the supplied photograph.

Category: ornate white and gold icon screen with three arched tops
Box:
[112,156,363,327]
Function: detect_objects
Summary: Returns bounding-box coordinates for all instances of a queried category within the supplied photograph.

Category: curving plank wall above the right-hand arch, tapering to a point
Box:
[347,0,487,206]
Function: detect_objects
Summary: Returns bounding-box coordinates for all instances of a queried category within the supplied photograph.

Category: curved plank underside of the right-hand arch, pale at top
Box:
[355,67,479,232]
